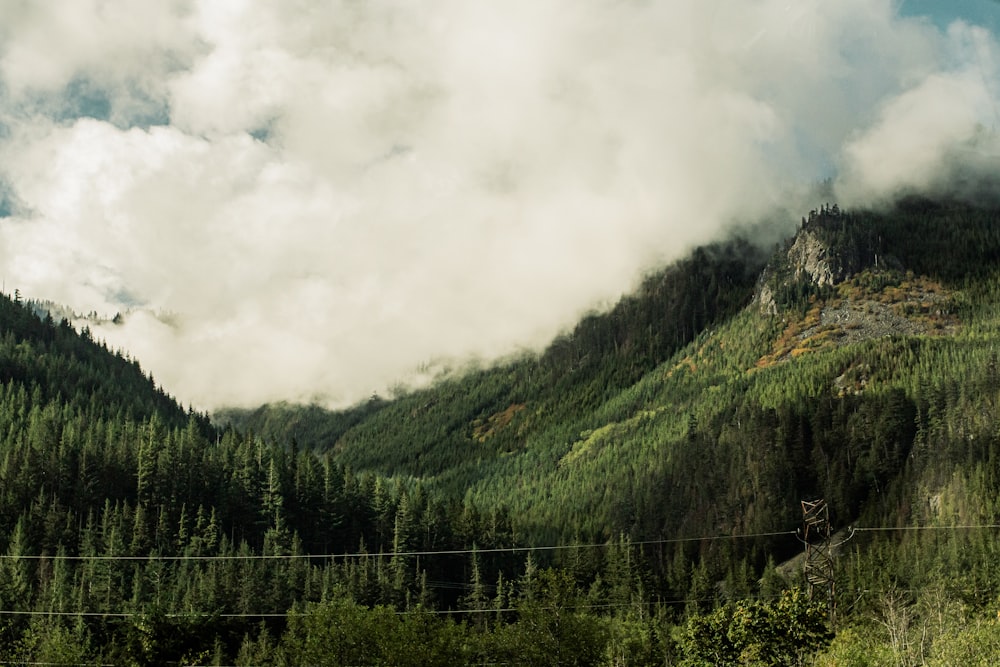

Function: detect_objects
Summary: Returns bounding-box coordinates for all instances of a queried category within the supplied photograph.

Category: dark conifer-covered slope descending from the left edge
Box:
[0,274,540,665]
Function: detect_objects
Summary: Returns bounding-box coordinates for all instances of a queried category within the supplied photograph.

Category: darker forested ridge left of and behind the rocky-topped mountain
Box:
[224,234,766,534]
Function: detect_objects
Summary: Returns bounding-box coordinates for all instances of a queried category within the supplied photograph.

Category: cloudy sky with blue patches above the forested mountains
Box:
[0,0,1000,410]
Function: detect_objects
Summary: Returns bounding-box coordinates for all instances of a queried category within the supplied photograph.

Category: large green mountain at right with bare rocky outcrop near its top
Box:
[219,197,1000,664]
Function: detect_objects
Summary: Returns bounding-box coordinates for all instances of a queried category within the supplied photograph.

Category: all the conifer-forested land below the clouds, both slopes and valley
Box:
[0,200,1000,665]
